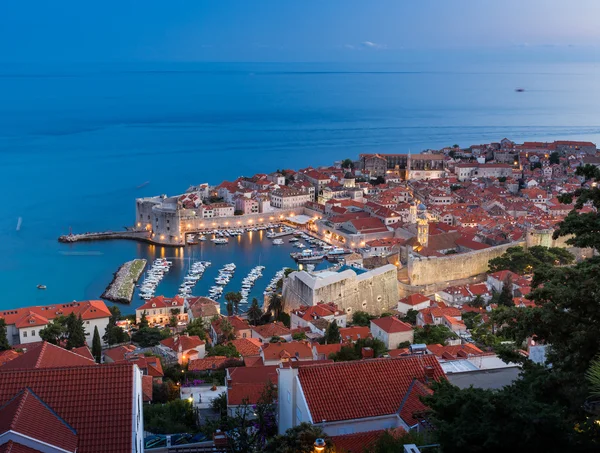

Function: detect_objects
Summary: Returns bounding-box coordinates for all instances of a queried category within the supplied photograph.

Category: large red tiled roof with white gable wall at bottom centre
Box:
[298,356,444,422]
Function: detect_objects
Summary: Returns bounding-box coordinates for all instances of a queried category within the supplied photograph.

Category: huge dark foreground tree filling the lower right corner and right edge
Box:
[425,166,600,452]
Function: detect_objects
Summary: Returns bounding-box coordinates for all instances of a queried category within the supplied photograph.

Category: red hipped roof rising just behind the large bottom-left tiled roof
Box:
[0,342,96,374]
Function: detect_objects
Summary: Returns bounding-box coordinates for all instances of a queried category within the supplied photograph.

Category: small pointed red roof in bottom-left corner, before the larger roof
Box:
[0,388,77,452]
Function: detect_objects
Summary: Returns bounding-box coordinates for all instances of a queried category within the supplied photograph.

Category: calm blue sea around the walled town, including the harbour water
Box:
[0,58,600,313]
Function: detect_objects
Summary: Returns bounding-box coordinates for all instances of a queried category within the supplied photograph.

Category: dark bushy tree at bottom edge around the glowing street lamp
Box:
[263,422,335,453]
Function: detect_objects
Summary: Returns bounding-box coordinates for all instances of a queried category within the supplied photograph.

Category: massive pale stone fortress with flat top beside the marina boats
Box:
[283,264,398,316]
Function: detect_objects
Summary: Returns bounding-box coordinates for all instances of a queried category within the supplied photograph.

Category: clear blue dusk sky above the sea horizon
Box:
[0,0,600,62]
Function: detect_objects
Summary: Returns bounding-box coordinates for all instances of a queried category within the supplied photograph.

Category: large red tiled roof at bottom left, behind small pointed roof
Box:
[0,364,134,453]
